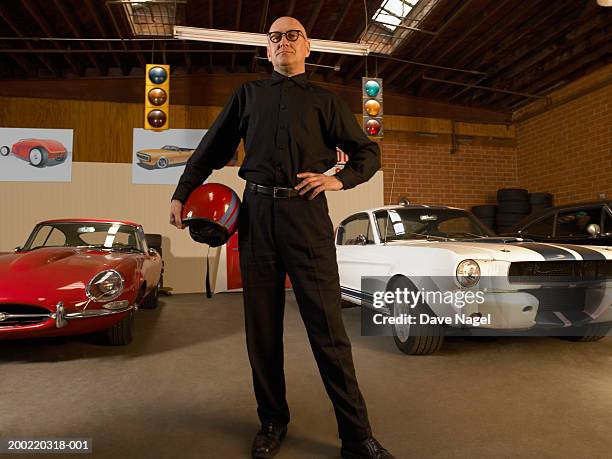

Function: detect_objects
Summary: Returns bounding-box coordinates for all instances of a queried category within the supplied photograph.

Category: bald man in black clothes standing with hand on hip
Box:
[170,17,393,458]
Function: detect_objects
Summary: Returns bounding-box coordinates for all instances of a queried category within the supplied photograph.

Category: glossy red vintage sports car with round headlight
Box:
[0,219,162,345]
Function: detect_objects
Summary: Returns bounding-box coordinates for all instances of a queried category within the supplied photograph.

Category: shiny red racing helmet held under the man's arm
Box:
[182,183,240,247]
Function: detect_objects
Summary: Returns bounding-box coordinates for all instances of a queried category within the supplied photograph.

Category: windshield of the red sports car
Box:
[22,222,143,252]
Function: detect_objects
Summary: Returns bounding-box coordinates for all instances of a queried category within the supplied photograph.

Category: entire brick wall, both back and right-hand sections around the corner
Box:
[382,65,612,208]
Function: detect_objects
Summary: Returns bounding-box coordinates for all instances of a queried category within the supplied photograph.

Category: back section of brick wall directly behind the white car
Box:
[382,131,517,209]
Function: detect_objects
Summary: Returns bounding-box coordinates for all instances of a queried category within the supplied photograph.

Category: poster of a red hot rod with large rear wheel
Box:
[0,128,73,182]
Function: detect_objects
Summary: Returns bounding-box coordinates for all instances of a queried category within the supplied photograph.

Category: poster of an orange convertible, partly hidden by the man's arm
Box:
[132,128,207,185]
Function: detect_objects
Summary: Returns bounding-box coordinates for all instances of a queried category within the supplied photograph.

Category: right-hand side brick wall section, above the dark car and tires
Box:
[515,65,612,204]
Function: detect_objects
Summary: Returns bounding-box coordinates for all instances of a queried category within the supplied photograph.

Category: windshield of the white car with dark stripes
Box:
[375,208,493,242]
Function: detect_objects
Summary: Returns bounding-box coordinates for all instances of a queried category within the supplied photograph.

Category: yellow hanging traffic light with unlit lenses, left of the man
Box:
[145,64,170,131]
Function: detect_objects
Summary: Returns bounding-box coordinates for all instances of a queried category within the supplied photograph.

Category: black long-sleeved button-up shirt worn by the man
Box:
[172,71,380,202]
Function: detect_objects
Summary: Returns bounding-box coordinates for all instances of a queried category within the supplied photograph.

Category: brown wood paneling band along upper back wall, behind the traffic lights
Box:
[0,97,515,163]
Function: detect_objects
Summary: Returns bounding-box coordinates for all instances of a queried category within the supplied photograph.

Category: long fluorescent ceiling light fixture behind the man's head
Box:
[174,26,370,56]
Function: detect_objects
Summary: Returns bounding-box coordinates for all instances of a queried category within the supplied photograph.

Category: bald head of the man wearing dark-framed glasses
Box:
[267,16,310,76]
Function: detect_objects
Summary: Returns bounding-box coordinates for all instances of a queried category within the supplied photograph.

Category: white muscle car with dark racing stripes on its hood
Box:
[335,204,612,354]
